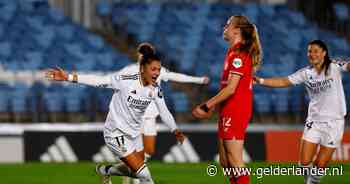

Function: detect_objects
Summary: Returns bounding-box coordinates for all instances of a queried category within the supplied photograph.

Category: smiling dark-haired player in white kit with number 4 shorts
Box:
[255,40,350,184]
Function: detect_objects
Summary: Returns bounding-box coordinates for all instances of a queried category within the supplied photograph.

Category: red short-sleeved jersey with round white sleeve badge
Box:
[220,44,253,119]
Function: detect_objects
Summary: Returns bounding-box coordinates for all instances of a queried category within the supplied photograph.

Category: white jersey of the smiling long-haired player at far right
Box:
[288,62,347,122]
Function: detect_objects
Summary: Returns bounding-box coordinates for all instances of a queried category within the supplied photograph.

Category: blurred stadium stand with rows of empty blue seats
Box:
[0,0,350,121]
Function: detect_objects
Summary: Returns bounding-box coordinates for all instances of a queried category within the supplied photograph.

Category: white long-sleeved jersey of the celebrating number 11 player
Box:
[74,72,177,137]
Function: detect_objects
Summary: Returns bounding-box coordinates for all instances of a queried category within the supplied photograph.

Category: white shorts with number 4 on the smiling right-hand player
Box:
[302,119,344,148]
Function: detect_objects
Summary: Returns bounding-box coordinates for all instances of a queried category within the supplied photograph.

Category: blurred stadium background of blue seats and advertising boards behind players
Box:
[0,0,350,178]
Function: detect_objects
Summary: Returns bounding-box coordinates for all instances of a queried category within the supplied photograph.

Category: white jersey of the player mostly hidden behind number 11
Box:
[117,63,204,118]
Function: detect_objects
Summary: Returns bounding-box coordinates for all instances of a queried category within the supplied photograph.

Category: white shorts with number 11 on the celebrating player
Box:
[104,130,143,158]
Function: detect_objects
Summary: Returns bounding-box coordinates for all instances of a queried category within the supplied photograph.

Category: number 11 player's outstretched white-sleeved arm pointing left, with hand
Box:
[45,67,112,88]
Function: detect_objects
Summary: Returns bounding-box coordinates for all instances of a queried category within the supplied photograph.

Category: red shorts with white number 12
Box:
[218,116,250,140]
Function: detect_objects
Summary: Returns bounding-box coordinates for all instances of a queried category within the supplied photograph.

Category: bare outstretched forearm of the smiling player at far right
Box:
[254,76,293,88]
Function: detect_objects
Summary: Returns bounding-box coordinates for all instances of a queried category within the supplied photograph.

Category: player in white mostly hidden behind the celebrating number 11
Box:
[118,43,209,160]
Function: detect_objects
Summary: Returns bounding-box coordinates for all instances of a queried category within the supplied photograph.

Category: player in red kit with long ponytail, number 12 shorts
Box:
[192,16,262,184]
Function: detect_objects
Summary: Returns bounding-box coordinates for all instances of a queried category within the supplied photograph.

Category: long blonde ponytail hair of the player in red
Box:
[231,15,263,71]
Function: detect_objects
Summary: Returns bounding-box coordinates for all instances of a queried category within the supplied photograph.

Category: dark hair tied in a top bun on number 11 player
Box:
[137,43,160,66]
